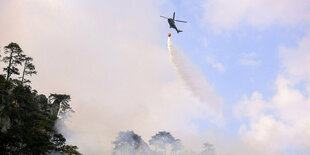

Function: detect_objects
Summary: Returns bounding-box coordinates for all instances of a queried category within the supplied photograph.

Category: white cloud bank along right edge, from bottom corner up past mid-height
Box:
[235,34,310,154]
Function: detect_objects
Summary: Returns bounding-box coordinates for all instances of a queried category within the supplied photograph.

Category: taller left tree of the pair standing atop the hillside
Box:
[3,42,23,80]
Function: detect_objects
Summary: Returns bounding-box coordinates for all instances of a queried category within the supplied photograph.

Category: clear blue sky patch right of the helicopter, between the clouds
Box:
[163,1,306,102]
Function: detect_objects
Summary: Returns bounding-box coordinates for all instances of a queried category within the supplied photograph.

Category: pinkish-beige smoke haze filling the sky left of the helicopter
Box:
[0,0,221,154]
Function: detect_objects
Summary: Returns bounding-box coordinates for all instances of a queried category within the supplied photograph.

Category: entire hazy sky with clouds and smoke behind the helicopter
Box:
[0,0,310,155]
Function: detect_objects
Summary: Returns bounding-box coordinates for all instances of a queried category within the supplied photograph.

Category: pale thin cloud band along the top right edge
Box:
[204,0,310,30]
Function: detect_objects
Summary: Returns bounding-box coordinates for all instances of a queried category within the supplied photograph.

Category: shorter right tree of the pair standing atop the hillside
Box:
[21,55,37,84]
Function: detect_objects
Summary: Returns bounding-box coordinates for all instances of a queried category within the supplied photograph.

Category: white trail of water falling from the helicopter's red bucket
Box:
[168,37,222,110]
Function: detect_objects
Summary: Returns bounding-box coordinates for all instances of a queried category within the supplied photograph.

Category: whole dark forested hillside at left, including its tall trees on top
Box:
[0,43,80,155]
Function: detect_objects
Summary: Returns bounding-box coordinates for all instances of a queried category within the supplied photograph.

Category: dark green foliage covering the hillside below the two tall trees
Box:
[0,72,80,155]
